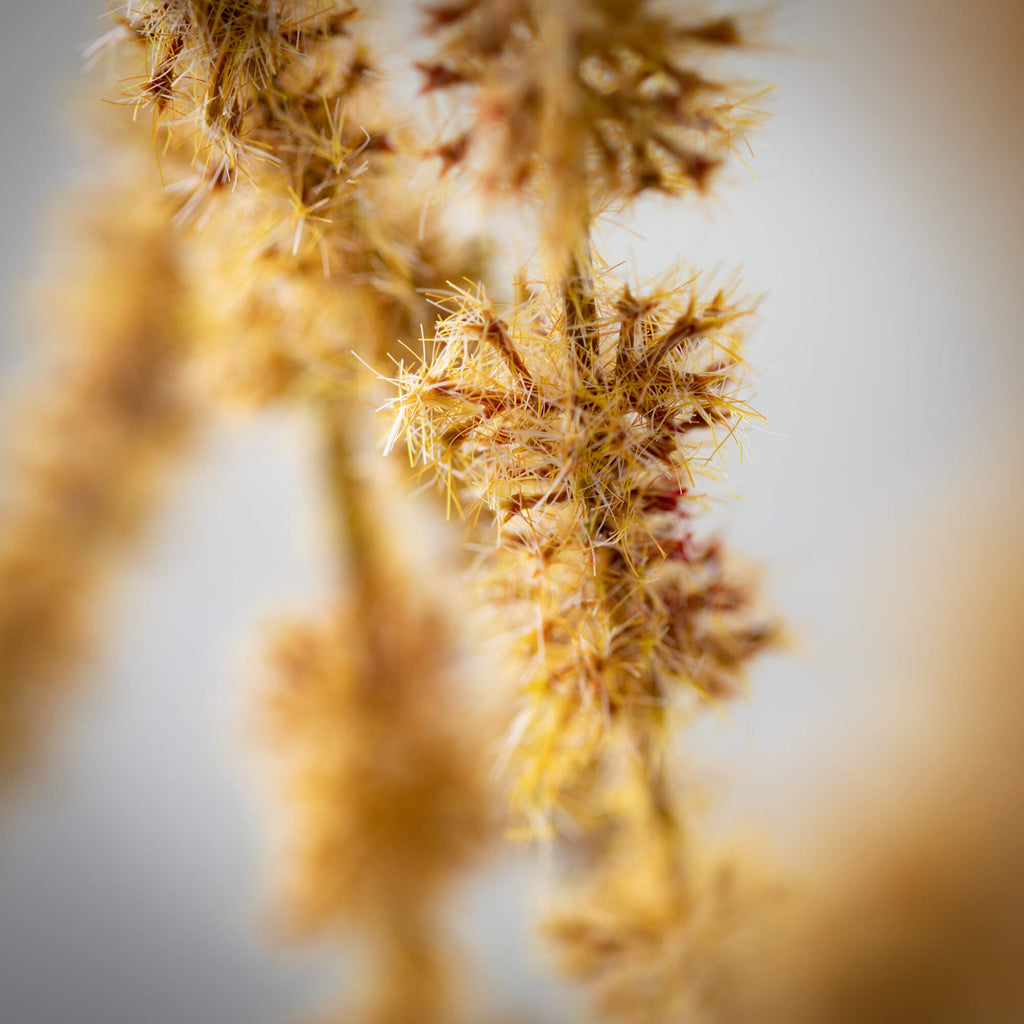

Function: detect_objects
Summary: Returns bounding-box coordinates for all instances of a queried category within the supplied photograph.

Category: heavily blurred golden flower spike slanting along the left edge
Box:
[0,159,198,783]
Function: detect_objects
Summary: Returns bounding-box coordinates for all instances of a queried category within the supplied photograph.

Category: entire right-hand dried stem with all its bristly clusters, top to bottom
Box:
[392,0,777,1021]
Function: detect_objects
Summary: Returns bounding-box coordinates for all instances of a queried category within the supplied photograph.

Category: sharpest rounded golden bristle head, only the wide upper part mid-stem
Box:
[392,268,756,550]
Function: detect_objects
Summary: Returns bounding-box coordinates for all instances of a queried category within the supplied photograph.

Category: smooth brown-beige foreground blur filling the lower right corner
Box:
[727,501,1024,1024]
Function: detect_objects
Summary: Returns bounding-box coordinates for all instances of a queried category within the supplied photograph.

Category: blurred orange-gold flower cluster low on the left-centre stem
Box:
[265,600,489,932]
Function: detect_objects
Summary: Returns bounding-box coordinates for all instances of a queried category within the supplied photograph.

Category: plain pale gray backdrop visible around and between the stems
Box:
[0,0,1024,1024]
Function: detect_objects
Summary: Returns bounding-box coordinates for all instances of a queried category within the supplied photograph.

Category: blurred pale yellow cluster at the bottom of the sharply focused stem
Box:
[544,758,776,1024]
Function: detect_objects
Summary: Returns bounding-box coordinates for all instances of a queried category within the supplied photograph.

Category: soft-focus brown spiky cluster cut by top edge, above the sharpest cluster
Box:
[420,0,756,241]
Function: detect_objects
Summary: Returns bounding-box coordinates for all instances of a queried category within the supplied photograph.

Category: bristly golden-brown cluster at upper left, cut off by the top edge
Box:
[103,0,482,403]
